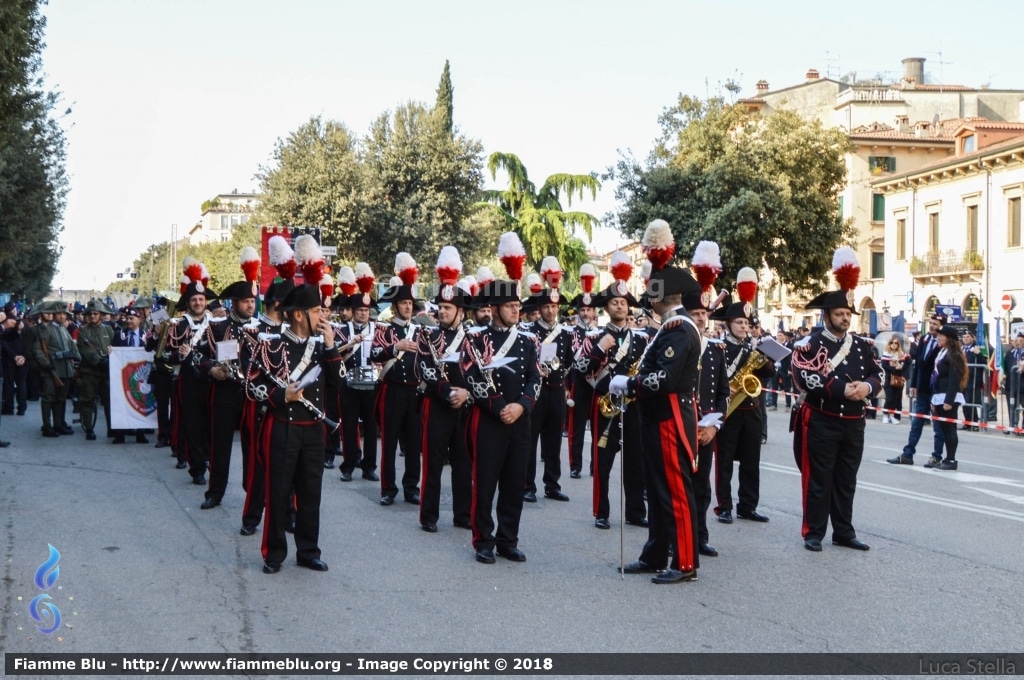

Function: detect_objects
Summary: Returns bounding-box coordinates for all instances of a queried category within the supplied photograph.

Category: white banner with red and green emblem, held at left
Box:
[111,347,157,430]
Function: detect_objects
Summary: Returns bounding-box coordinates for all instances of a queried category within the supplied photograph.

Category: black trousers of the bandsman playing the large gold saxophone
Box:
[715,405,763,513]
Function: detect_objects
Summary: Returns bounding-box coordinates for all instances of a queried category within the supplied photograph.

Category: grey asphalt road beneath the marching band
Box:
[0,403,1024,667]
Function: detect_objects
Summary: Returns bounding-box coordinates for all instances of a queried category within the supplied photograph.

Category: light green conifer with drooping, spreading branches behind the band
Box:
[483,152,601,278]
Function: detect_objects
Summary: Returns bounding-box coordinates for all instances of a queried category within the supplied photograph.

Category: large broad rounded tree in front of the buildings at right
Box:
[608,96,854,291]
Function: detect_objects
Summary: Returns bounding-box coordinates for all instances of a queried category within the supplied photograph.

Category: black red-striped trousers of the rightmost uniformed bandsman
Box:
[793,405,864,541]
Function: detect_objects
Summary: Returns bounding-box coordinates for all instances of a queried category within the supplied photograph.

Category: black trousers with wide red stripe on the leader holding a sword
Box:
[640,401,699,571]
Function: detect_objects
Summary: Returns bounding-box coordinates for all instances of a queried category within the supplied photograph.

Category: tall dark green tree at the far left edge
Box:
[0,0,71,299]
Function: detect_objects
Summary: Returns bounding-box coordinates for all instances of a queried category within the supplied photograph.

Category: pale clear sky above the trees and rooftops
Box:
[43,0,1024,289]
